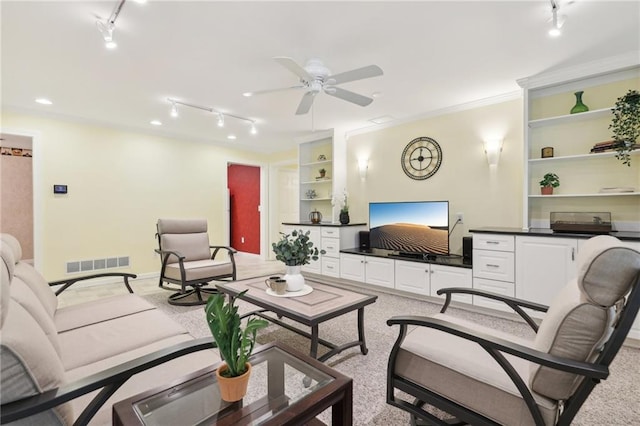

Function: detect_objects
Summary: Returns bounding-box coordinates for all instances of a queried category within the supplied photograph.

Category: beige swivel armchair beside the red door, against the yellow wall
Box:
[156,219,236,305]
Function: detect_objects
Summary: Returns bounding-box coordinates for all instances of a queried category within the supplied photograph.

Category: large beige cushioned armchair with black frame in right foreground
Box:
[387,236,640,425]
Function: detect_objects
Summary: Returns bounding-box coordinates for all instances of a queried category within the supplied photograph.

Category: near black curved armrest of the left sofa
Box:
[0,337,217,425]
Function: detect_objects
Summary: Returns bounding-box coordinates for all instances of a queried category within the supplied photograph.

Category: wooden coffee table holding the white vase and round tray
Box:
[216,277,378,362]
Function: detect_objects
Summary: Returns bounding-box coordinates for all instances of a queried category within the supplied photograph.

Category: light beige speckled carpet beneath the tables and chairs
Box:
[144,282,640,426]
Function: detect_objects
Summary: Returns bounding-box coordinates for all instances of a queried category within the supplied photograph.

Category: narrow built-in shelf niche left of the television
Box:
[298,137,334,223]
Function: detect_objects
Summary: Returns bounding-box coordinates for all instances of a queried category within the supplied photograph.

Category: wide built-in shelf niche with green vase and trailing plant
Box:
[518,61,640,231]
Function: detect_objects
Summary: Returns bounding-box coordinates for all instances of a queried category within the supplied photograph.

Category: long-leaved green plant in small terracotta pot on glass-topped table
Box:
[204,290,268,402]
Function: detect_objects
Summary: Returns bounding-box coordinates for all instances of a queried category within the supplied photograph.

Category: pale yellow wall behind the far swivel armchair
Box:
[2,112,295,280]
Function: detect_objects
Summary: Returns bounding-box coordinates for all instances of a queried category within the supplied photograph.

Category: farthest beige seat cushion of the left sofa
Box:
[54,293,156,333]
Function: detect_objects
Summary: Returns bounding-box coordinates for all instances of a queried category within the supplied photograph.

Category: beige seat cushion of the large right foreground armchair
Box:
[395,314,558,425]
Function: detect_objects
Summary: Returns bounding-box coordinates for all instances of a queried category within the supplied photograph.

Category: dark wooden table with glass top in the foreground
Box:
[113,342,353,426]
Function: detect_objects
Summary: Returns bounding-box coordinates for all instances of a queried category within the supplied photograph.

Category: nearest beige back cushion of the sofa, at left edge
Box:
[0,300,74,425]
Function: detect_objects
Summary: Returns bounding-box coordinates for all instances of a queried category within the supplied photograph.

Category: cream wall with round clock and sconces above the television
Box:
[346,99,523,253]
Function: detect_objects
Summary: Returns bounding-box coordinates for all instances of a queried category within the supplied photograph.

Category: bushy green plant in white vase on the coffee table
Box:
[271,229,326,291]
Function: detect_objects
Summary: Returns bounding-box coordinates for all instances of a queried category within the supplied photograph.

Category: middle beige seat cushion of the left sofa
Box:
[58,309,187,370]
